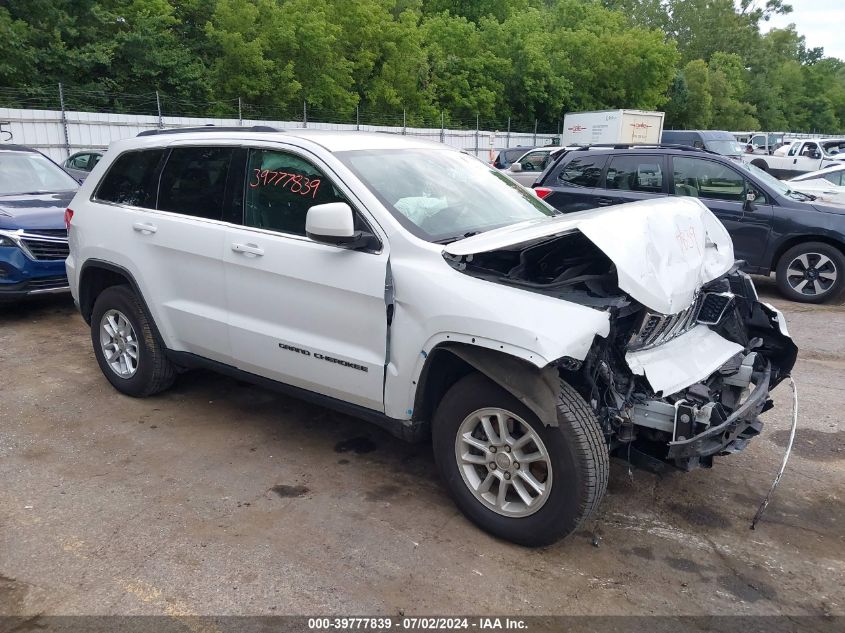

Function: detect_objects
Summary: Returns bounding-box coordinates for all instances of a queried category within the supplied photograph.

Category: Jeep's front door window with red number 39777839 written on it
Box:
[244,149,347,235]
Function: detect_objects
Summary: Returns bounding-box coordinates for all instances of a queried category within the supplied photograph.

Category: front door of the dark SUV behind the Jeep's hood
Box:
[672,156,773,268]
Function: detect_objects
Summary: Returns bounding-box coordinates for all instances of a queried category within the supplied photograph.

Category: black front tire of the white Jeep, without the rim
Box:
[432,373,610,547]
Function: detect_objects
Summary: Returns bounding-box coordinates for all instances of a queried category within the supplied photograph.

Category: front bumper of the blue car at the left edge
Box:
[0,246,70,302]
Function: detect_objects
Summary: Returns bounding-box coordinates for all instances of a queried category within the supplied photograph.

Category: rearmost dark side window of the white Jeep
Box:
[94,149,164,209]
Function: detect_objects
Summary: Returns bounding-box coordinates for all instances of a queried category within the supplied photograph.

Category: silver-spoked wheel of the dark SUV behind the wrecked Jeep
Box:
[775,242,845,303]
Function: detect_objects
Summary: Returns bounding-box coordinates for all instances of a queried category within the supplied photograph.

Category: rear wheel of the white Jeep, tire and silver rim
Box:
[91,286,176,397]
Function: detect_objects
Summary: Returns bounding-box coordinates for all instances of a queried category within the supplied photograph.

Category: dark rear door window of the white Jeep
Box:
[158,147,235,220]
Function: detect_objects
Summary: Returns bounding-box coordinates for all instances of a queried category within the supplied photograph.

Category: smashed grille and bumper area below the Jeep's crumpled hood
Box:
[576,268,797,470]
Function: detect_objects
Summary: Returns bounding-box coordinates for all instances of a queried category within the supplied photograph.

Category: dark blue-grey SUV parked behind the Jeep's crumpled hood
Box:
[535,147,845,303]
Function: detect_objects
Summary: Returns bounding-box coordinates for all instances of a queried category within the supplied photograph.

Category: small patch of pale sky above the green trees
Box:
[760,0,845,61]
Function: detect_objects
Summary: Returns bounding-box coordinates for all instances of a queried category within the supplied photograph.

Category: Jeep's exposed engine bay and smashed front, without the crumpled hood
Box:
[446,231,797,471]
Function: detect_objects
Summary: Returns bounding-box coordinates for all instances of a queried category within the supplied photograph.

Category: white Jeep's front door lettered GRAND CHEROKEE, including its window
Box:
[223,149,388,411]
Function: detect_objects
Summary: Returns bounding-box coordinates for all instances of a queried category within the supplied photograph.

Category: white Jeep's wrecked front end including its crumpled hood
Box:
[444,199,797,470]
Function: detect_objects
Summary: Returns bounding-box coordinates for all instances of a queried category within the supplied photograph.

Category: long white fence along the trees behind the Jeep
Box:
[0,108,554,162]
